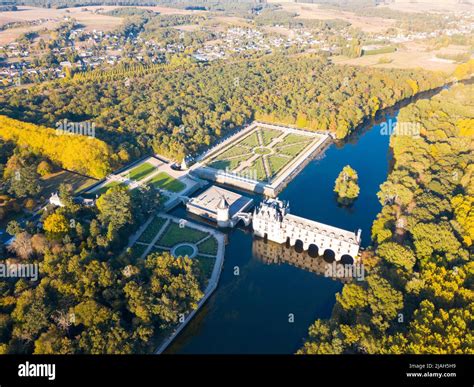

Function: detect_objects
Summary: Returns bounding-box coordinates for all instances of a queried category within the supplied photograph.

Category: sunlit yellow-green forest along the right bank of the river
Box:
[299,83,474,354]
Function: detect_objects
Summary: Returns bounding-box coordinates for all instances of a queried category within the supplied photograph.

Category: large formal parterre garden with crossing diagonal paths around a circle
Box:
[205,124,319,182]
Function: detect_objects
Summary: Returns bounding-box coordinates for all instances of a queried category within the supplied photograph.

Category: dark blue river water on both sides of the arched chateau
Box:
[167,111,398,354]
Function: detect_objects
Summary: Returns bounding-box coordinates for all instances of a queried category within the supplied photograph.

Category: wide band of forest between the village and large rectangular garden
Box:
[0,54,454,160]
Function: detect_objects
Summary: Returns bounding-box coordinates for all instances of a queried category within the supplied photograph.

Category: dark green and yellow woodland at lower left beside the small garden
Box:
[0,153,209,354]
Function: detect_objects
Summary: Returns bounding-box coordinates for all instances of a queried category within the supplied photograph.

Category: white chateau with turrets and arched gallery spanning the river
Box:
[252,199,361,261]
